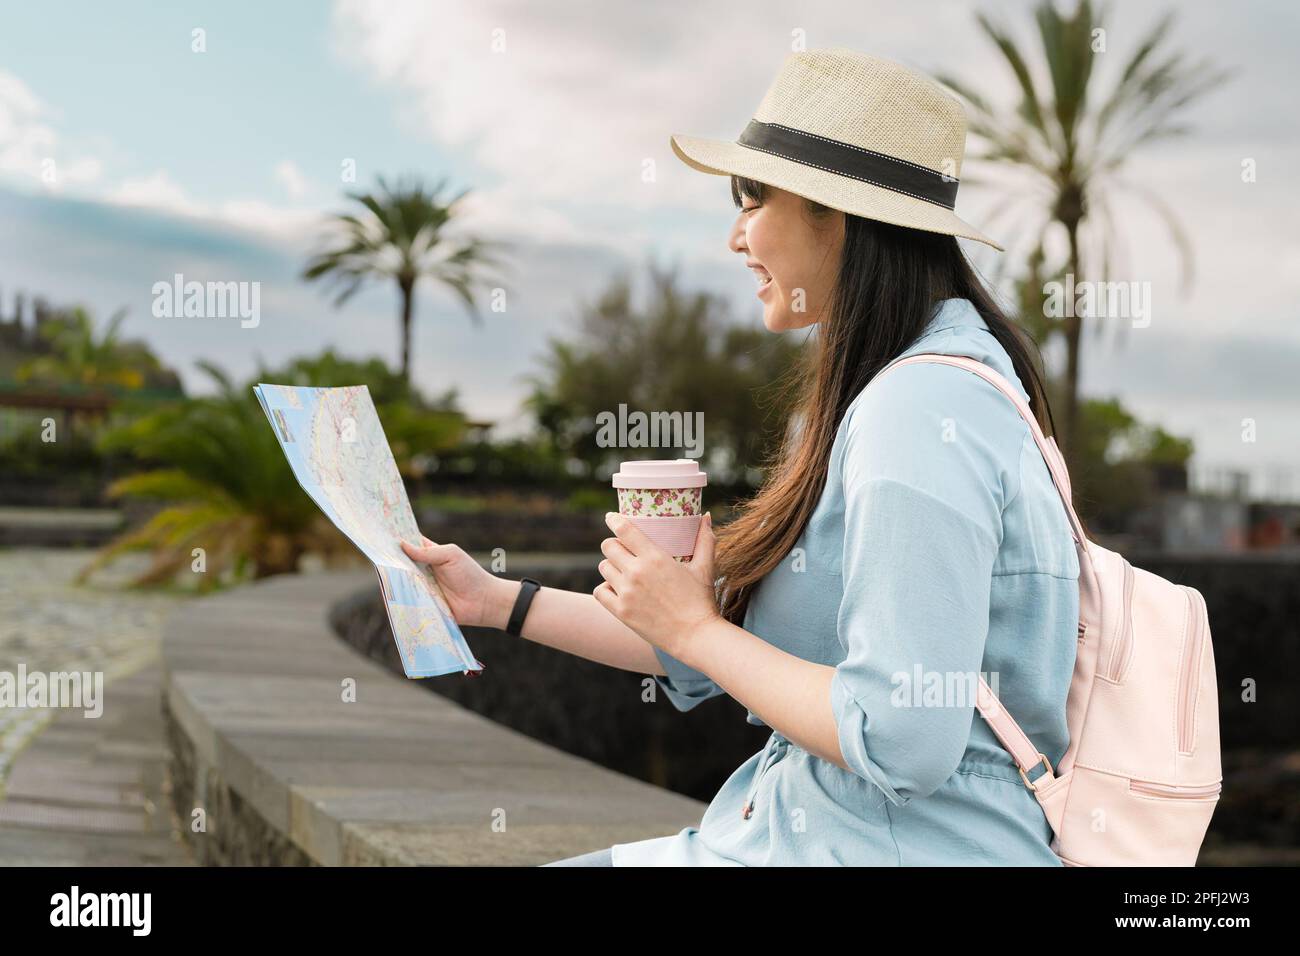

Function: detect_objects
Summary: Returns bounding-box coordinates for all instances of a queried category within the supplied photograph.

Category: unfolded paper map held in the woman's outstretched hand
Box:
[254,385,482,678]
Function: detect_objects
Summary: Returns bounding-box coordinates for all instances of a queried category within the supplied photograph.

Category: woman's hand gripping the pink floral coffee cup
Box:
[593,512,722,659]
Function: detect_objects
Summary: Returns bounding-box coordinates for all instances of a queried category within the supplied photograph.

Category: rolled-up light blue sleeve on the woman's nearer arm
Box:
[831,365,1024,805]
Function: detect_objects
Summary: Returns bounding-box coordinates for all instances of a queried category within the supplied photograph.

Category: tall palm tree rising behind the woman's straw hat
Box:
[940,0,1229,453]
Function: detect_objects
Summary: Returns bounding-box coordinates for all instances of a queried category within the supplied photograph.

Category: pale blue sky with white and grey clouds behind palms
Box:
[0,0,1300,494]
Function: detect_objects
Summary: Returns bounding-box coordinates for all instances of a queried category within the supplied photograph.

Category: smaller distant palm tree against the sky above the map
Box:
[303,177,499,381]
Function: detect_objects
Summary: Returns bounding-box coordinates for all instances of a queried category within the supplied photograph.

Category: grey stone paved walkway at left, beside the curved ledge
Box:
[0,549,189,865]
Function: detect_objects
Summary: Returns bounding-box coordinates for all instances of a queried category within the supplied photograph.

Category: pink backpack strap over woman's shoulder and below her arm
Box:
[872,352,1100,790]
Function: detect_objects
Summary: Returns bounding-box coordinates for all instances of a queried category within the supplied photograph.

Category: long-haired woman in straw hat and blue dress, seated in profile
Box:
[408,49,1079,866]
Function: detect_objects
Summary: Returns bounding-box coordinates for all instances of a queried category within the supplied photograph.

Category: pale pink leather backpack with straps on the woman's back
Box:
[885,352,1223,866]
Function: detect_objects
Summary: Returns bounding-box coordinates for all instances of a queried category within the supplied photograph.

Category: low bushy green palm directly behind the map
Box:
[81,352,465,591]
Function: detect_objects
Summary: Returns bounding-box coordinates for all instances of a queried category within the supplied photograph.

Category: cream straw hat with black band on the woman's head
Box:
[672,48,1002,250]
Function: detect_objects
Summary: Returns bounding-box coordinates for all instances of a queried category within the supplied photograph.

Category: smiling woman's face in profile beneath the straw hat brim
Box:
[727,186,844,332]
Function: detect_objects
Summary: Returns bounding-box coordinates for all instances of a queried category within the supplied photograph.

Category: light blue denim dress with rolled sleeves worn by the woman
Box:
[612,299,1079,866]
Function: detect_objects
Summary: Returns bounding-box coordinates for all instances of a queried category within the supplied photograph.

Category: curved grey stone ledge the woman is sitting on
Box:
[163,572,705,865]
